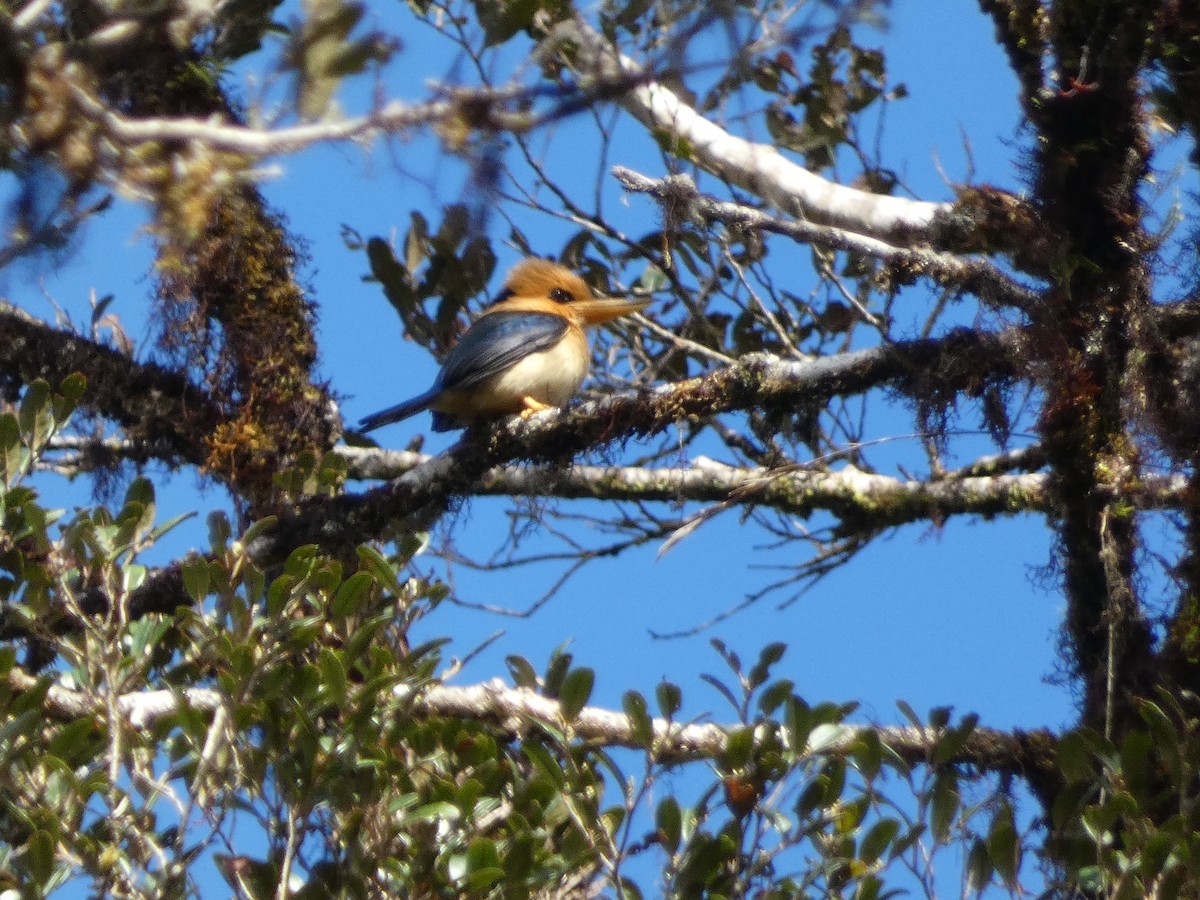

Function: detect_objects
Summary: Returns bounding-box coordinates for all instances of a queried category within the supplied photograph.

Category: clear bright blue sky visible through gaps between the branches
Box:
[0,0,1099,897]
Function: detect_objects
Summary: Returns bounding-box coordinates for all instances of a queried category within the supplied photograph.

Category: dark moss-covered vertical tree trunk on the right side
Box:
[1027,2,1158,731]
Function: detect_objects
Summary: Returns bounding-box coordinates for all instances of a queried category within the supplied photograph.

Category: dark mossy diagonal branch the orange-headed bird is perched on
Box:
[16,330,1018,637]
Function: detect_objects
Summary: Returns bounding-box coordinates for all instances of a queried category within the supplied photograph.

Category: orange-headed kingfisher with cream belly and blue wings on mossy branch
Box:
[359,258,650,432]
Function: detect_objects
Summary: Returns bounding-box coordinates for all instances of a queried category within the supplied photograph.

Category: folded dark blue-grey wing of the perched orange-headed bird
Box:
[437,311,566,390]
